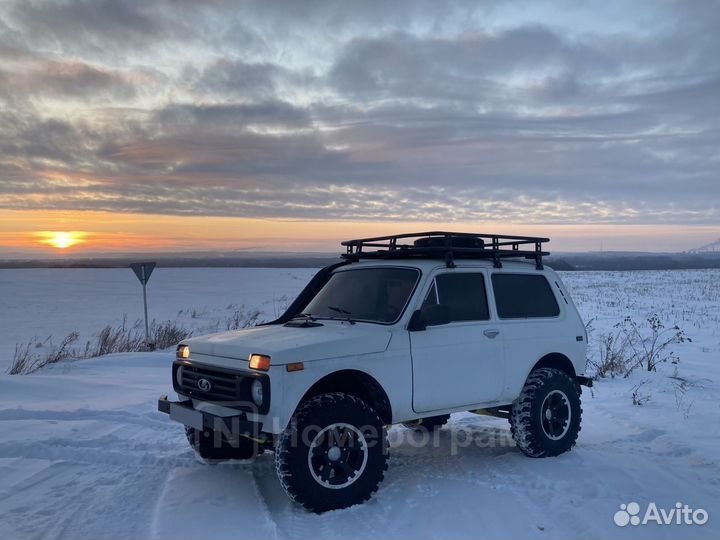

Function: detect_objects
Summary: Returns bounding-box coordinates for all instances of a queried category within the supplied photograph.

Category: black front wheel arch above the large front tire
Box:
[296,369,392,424]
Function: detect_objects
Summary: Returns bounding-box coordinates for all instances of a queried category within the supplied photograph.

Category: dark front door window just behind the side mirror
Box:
[435,273,490,322]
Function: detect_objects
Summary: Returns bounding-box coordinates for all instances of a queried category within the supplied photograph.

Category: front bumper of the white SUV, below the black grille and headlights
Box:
[158,396,266,440]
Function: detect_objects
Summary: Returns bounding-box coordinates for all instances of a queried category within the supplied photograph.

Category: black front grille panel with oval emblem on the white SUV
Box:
[173,360,270,414]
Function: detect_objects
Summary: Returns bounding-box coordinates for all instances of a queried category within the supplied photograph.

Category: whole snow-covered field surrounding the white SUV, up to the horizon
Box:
[0,269,720,539]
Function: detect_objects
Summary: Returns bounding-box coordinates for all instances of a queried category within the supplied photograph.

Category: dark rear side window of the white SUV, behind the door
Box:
[492,274,560,319]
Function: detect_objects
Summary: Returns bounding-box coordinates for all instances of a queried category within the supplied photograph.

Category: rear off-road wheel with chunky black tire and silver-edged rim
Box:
[510,368,582,457]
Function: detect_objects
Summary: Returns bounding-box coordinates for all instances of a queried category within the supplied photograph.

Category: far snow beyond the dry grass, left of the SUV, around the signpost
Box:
[0,268,316,372]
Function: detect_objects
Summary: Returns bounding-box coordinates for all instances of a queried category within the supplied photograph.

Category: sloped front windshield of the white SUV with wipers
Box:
[302,267,420,323]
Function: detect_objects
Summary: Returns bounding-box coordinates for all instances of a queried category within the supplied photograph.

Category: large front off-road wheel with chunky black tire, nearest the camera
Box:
[275,392,388,513]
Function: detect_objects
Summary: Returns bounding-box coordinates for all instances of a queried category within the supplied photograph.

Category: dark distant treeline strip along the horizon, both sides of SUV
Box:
[0,252,720,271]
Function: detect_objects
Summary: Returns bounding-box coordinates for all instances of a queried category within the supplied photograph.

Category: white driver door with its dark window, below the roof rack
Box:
[410,269,505,412]
